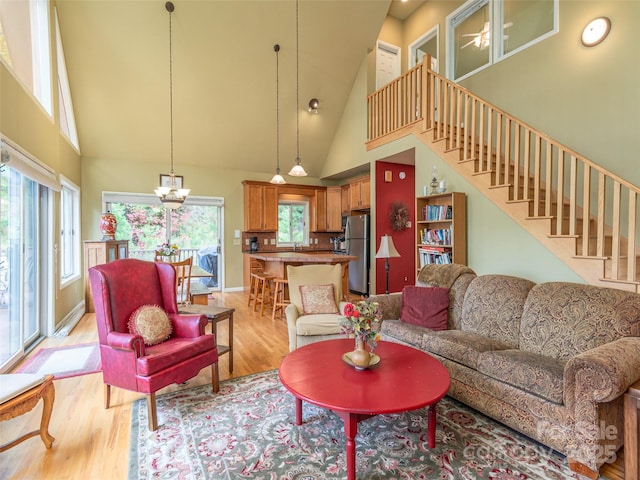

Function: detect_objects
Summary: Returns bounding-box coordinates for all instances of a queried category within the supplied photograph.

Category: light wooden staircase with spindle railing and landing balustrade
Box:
[367,57,640,293]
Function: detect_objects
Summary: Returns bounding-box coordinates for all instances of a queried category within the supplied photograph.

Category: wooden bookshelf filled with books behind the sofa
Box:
[416,192,467,271]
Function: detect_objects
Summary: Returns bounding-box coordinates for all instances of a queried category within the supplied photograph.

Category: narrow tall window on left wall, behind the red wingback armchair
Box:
[60,176,80,287]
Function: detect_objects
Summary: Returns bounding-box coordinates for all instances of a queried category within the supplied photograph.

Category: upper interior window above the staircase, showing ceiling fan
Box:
[447,0,558,81]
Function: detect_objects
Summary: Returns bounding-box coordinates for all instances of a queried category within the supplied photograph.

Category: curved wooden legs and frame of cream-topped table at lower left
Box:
[0,375,55,452]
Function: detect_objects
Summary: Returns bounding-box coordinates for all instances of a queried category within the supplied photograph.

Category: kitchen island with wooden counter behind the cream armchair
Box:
[250,251,358,296]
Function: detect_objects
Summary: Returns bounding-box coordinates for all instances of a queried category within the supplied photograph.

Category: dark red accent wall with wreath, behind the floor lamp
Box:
[372,160,416,294]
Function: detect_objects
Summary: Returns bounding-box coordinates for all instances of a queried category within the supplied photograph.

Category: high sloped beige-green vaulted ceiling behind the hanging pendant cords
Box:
[57,0,416,177]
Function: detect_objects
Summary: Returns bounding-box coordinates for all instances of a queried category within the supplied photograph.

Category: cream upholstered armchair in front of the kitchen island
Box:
[285,265,346,351]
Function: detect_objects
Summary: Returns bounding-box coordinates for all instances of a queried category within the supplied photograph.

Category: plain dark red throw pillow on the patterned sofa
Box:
[400,286,449,330]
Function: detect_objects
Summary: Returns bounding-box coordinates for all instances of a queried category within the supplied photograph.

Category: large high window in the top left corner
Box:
[0,0,53,116]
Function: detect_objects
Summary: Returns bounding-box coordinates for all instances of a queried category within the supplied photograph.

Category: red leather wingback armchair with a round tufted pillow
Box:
[89,258,219,430]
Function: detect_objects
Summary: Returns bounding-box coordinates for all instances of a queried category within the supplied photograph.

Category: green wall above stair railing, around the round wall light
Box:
[461,0,640,185]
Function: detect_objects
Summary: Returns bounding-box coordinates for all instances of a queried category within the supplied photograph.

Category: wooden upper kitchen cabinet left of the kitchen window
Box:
[244,182,278,232]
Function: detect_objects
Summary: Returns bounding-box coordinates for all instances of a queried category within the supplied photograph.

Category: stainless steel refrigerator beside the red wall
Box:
[344,215,369,296]
